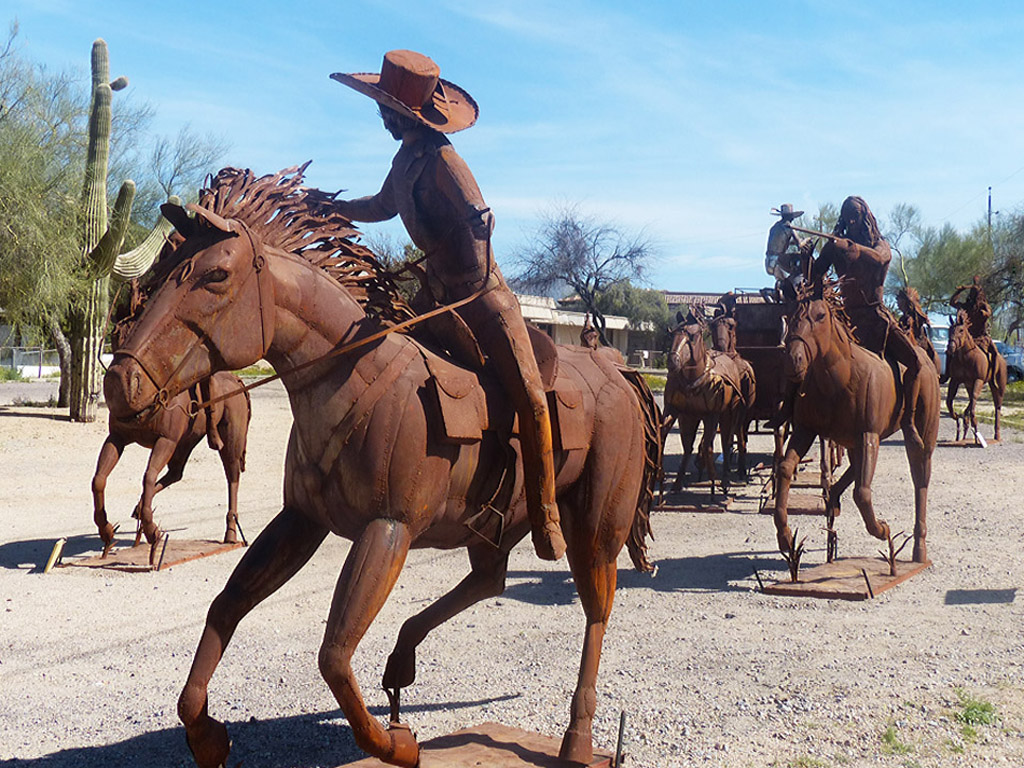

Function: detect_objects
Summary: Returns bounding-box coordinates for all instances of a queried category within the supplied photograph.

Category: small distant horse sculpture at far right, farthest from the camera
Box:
[946,309,1008,444]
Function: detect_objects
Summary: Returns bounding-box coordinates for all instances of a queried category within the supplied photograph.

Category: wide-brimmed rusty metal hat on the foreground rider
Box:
[331,50,480,133]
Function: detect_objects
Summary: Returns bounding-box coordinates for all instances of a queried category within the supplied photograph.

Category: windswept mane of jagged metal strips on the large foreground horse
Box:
[139,162,416,326]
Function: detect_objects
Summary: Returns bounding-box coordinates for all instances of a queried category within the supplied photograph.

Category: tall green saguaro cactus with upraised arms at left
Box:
[71,39,135,422]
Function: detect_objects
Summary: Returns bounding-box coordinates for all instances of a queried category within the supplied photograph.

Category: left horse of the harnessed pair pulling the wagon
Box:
[662,313,745,501]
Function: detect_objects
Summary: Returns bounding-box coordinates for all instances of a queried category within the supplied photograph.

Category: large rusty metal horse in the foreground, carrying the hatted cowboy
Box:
[103,169,660,767]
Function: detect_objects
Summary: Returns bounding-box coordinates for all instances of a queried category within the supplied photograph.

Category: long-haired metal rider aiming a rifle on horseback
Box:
[810,196,921,450]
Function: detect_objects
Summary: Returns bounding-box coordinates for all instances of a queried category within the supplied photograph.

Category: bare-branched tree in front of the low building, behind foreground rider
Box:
[510,205,654,345]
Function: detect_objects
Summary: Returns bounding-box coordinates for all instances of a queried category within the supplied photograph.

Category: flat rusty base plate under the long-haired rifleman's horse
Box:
[764,557,932,600]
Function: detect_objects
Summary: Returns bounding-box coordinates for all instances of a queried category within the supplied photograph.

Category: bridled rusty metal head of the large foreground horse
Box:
[103,204,273,418]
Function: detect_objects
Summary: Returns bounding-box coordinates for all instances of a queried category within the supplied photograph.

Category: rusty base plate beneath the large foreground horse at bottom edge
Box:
[341,723,612,768]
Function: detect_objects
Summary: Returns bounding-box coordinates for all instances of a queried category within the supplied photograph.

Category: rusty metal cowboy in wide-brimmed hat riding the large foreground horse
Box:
[331,50,565,560]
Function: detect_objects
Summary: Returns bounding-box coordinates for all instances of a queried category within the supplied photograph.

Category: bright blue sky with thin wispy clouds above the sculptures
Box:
[8,0,1024,291]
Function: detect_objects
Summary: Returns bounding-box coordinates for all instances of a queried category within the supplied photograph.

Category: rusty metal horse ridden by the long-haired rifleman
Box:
[775,284,940,581]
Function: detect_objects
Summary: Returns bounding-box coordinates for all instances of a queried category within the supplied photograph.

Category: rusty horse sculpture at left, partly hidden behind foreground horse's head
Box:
[92,372,252,555]
